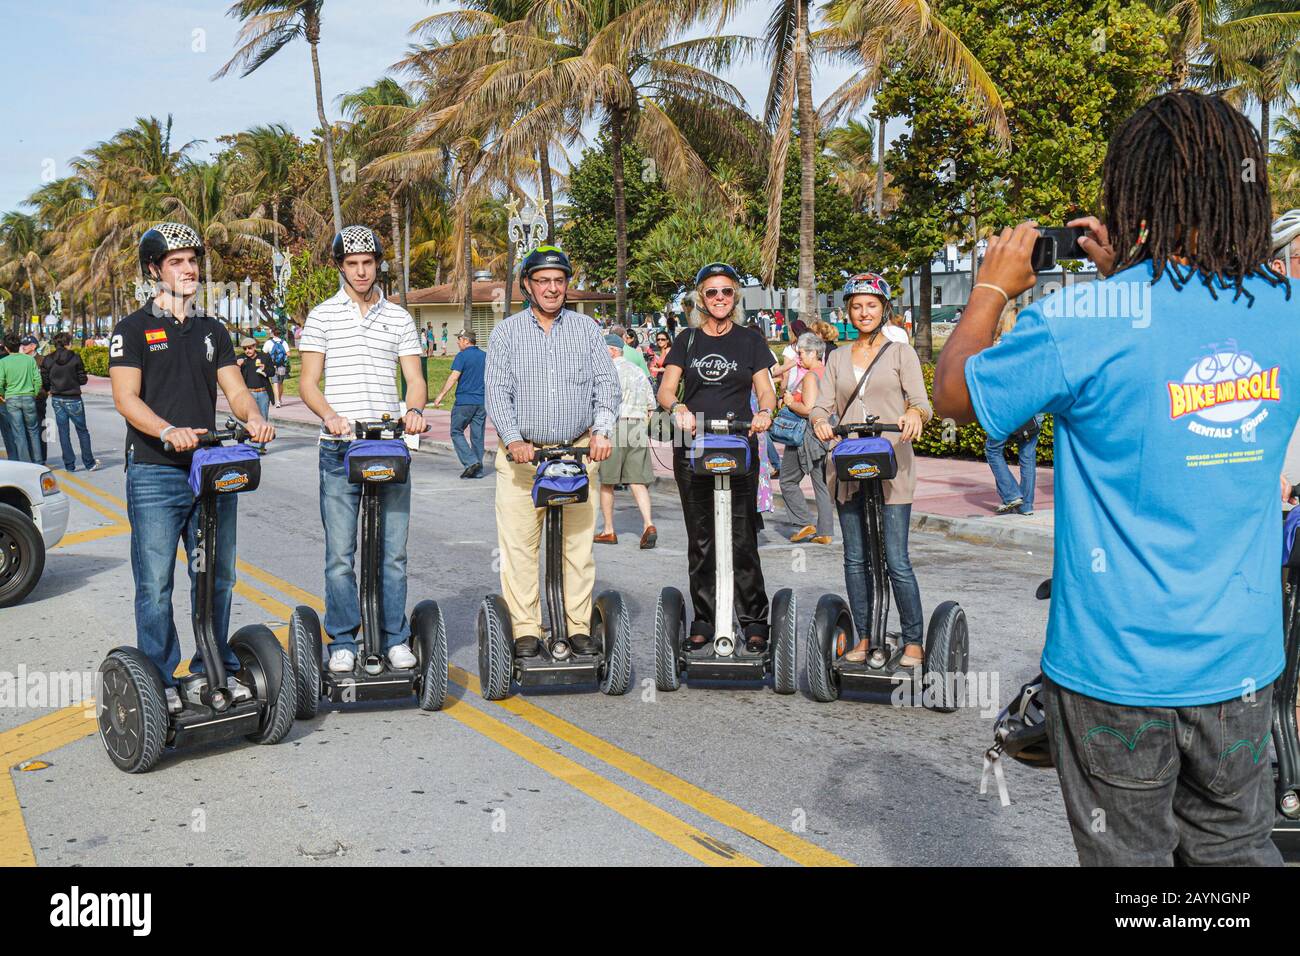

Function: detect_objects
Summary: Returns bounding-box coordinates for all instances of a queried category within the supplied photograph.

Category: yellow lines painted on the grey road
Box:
[0,475,850,866]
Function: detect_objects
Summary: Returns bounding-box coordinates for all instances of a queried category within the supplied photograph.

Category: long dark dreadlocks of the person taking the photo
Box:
[1102,90,1291,306]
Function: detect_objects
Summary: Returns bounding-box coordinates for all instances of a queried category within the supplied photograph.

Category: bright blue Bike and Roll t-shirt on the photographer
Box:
[966,261,1300,706]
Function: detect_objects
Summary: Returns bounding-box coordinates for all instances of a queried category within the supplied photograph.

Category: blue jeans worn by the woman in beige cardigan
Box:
[837,490,924,645]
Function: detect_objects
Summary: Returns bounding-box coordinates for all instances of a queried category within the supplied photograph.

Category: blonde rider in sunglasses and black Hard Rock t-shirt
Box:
[659,263,776,650]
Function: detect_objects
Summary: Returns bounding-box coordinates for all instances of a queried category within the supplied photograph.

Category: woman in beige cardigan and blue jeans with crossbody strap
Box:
[809,273,933,667]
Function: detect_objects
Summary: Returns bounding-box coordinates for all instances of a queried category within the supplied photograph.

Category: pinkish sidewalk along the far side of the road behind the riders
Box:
[82,376,1053,551]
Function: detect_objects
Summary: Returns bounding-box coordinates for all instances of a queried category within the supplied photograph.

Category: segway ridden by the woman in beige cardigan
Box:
[807,415,969,713]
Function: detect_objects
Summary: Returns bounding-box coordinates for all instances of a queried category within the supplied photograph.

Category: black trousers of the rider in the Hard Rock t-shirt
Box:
[672,449,768,640]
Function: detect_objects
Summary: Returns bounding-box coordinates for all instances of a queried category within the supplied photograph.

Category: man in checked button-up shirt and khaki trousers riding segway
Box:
[480,246,625,696]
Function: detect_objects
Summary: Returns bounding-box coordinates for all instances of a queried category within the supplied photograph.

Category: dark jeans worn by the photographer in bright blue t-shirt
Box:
[1043,678,1282,866]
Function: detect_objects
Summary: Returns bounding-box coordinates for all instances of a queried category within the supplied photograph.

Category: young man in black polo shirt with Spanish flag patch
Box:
[108,222,276,713]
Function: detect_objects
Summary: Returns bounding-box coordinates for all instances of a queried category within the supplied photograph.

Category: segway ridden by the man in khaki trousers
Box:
[478,445,632,700]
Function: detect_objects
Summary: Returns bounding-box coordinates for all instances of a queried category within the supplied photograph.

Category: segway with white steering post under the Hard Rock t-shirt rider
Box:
[654,416,798,693]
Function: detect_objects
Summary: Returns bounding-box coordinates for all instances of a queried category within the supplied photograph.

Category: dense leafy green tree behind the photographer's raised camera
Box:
[874,0,1170,359]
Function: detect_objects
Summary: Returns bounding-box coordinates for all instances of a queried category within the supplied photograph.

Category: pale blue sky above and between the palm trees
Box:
[0,0,873,211]
